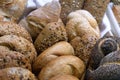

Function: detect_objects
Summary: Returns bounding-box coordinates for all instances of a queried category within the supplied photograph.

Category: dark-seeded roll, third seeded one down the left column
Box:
[0,46,31,70]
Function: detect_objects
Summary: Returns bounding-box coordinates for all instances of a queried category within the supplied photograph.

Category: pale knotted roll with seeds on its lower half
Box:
[66,10,100,64]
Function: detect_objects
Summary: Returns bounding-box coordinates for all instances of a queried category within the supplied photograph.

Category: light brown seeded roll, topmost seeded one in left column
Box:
[0,21,32,42]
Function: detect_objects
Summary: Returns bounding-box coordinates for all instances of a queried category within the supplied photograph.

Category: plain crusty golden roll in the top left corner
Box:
[0,0,27,21]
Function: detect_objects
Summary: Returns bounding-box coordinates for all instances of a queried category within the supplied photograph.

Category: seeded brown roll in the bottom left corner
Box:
[0,67,37,80]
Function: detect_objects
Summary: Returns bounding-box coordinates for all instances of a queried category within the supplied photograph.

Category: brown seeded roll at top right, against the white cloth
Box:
[84,0,110,25]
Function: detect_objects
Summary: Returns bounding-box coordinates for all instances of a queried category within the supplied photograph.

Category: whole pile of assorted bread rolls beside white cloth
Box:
[0,0,120,80]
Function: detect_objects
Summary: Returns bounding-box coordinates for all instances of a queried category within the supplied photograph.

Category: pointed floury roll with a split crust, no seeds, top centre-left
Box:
[27,0,61,39]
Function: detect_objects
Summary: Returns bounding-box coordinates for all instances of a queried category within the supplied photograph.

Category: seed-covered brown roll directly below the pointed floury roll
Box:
[34,22,67,54]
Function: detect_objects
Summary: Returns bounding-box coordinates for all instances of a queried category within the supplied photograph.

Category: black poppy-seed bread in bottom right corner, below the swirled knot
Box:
[86,51,120,80]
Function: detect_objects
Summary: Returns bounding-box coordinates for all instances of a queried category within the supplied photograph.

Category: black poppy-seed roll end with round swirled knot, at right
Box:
[89,36,120,70]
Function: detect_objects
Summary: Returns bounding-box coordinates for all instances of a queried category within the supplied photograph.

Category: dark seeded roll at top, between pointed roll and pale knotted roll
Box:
[60,0,84,24]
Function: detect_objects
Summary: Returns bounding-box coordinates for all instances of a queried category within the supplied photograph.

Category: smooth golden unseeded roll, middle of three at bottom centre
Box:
[38,55,85,80]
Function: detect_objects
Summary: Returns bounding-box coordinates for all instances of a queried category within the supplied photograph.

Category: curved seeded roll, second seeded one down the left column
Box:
[0,35,37,63]
